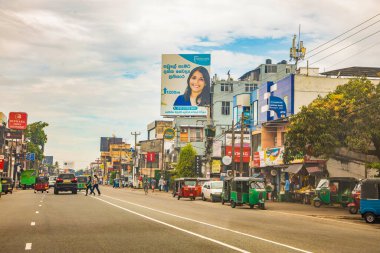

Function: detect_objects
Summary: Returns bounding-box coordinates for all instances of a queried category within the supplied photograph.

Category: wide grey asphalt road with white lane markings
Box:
[0,186,380,253]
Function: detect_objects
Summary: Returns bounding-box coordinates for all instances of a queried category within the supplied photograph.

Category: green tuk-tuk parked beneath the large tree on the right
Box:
[313,177,359,207]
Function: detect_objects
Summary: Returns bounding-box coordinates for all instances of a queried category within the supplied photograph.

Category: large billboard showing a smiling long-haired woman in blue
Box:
[161,54,211,116]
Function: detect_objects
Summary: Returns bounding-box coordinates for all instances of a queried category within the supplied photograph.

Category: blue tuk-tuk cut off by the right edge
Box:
[359,178,380,223]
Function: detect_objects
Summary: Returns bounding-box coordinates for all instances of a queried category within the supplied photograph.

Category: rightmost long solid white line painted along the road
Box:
[101,195,311,253]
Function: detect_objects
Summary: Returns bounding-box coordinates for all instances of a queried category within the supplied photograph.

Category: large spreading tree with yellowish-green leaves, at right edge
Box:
[284,78,380,162]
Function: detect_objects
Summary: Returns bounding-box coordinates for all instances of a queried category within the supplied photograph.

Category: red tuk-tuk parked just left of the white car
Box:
[173,178,202,200]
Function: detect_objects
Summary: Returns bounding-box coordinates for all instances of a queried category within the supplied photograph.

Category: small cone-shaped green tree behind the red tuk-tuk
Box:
[176,143,197,177]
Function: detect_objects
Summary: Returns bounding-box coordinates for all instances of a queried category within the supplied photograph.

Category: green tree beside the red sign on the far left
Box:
[25,121,49,161]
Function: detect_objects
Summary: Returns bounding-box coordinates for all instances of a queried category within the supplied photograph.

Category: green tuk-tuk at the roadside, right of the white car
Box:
[230,177,267,209]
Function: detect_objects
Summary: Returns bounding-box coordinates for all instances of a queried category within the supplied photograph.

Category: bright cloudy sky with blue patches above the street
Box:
[0,0,380,169]
